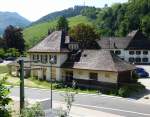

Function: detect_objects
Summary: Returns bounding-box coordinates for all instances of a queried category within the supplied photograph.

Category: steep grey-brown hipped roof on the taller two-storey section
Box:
[28,31,68,52]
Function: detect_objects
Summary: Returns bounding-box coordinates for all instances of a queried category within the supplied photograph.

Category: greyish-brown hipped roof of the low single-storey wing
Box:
[62,50,134,72]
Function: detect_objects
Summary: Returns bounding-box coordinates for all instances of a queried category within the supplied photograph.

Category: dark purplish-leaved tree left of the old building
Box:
[4,25,25,53]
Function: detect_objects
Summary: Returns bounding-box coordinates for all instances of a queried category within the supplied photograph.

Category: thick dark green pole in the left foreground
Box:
[18,60,24,113]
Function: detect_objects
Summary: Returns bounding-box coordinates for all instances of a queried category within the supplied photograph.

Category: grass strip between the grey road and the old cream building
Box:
[0,73,97,93]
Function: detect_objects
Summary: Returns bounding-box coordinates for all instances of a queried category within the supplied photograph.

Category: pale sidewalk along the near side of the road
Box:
[10,97,123,117]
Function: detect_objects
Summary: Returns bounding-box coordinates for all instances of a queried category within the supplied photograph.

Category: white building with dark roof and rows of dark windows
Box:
[98,30,150,64]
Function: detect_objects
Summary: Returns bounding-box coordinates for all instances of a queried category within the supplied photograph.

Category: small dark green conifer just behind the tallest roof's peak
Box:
[56,16,69,31]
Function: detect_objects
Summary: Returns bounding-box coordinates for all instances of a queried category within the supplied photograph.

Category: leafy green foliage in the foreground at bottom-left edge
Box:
[0,77,11,117]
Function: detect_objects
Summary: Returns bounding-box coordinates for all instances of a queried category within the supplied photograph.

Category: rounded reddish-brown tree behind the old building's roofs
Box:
[69,23,98,49]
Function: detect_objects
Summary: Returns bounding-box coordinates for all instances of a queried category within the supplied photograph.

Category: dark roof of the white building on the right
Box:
[97,30,150,49]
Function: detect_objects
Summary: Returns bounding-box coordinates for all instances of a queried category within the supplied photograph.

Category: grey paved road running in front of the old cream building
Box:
[10,87,150,117]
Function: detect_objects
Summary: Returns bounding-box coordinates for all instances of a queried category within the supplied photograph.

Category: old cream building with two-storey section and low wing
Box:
[24,31,135,87]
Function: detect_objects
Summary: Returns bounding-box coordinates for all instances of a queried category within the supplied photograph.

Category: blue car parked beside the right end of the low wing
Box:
[135,67,149,78]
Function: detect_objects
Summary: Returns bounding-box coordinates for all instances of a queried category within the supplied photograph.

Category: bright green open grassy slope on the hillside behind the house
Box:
[23,16,91,48]
